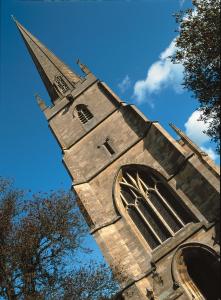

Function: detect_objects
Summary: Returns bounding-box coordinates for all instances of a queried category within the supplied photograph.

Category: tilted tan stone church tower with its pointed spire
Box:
[15,21,221,300]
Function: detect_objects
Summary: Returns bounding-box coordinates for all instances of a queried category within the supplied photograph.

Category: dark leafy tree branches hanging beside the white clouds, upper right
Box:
[172,0,221,151]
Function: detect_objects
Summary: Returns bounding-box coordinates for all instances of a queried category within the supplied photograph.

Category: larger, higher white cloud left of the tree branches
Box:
[134,39,183,103]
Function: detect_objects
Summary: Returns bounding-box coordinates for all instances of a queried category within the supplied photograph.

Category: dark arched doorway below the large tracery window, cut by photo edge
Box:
[176,244,221,300]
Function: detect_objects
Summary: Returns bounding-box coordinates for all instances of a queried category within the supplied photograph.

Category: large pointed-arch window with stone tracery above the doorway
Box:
[119,165,194,249]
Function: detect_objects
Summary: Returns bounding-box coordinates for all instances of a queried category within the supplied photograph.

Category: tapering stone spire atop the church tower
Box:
[12,16,82,102]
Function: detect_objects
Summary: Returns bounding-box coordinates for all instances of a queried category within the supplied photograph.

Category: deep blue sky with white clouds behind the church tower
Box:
[0,0,219,262]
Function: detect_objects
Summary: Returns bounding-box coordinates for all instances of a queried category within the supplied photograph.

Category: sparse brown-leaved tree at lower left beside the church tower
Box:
[0,177,118,300]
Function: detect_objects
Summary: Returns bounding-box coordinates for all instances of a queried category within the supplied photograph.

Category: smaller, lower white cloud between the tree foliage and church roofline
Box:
[184,110,218,161]
